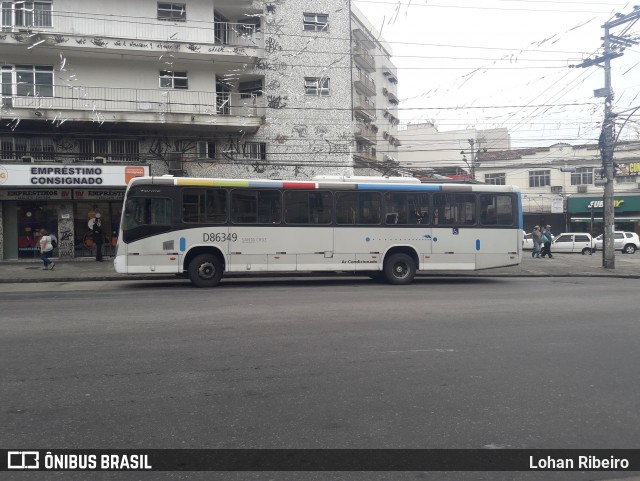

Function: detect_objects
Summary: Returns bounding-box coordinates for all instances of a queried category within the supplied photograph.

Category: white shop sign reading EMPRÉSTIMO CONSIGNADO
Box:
[0,164,149,188]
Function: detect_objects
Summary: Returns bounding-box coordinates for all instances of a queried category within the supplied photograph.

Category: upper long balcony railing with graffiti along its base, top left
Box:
[2,9,264,48]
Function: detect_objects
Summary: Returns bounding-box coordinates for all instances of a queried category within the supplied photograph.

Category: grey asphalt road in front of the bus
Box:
[0,278,640,480]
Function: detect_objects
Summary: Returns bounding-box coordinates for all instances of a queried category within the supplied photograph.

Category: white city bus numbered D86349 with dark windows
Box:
[114,176,523,287]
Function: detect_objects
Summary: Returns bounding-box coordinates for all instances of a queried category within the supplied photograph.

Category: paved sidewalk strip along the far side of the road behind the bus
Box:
[0,251,640,283]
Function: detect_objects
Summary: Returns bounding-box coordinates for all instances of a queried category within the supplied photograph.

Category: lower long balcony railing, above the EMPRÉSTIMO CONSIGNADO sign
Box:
[0,84,265,117]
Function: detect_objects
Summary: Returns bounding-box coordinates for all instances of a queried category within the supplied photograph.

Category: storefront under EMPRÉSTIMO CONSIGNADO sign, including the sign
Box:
[0,164,149,260]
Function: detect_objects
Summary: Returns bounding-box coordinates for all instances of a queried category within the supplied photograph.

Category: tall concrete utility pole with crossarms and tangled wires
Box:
[577,6,640,269]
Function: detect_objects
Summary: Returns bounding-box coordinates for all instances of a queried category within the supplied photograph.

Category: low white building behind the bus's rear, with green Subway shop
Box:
[475,142,640,235]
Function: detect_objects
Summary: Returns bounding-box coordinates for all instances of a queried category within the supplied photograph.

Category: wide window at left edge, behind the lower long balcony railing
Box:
[2,65,53,97]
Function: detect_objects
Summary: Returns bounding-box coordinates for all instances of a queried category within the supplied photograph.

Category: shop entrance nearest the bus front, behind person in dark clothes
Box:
[74,201,122,257]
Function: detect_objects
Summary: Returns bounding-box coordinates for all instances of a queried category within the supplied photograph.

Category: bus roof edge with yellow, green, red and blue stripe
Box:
[129,175,520,192]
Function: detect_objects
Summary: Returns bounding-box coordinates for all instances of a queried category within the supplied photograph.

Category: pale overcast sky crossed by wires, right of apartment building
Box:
[354,0,640,148]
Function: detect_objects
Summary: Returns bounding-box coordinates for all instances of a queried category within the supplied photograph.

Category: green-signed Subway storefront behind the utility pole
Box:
[567,193,640,236]
